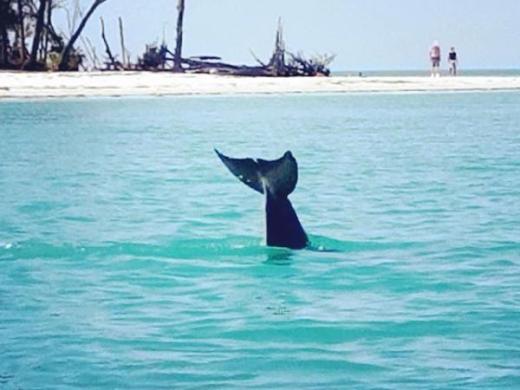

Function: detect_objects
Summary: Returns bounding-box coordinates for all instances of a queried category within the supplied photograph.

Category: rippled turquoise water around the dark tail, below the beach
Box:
[0,92,520,389]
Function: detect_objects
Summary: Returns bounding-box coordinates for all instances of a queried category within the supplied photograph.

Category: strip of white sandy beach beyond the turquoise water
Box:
[0,72,520,99]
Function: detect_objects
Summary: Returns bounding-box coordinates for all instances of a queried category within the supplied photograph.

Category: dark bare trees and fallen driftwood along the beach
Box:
[0,0,334,77]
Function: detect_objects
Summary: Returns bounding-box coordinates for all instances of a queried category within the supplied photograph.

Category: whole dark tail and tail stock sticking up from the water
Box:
[215,149,309,249]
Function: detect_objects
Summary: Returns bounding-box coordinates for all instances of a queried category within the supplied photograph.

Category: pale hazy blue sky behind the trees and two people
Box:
[63,0,520,70]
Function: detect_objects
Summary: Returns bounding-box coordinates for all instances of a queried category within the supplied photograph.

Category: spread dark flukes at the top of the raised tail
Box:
[215,149,298,198]
